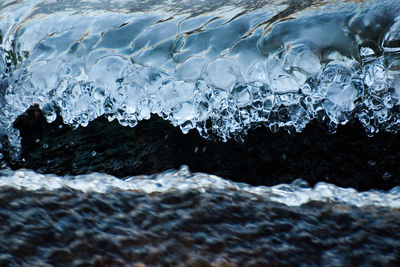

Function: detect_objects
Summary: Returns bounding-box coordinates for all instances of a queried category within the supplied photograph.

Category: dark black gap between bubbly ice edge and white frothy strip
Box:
[5,105,400,190]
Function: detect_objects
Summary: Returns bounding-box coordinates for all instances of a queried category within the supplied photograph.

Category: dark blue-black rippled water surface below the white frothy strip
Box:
[0,187,400,266]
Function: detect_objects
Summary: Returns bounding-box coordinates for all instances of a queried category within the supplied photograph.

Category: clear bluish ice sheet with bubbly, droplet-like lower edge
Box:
[0,1,400,158]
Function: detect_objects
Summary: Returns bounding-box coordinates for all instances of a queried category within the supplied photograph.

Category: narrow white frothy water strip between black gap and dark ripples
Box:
[0,166,400,208]
